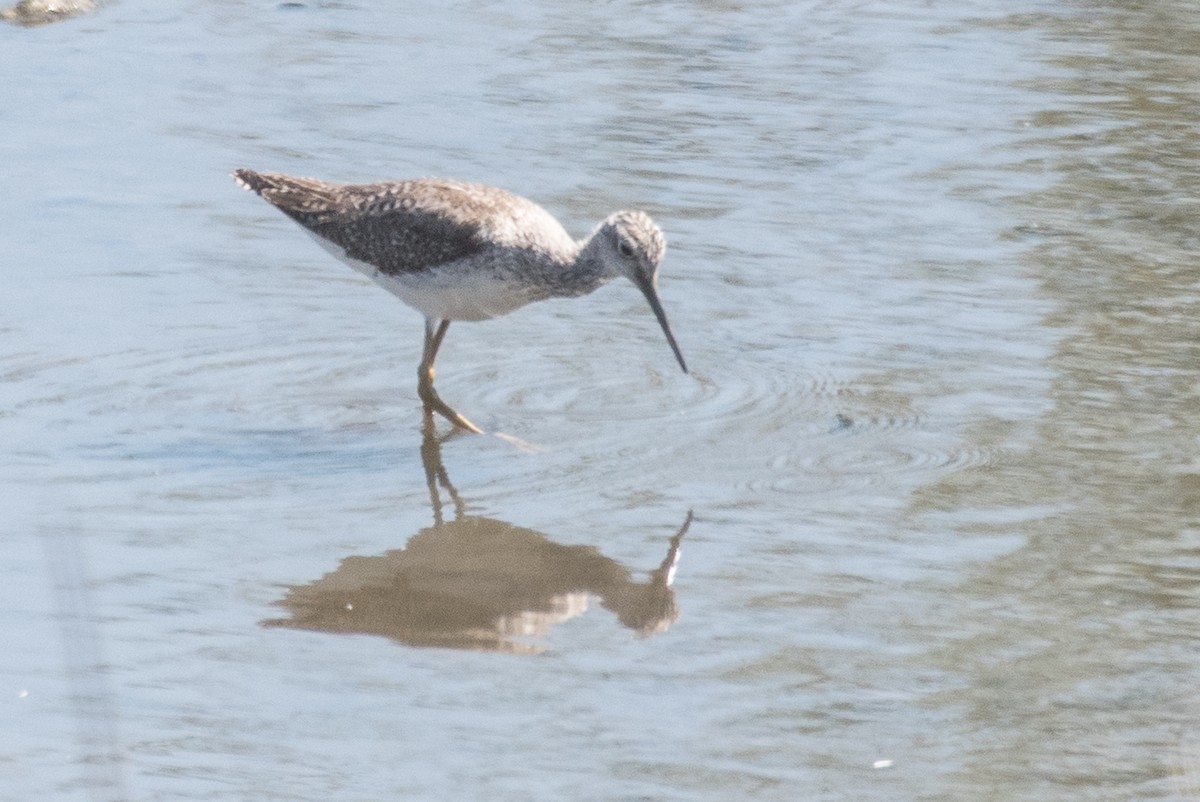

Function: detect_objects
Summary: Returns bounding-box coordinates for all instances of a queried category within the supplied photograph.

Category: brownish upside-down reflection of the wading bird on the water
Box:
[262,425,692,653]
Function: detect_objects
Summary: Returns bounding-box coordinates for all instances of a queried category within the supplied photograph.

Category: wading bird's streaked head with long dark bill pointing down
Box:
[592,211,688,373]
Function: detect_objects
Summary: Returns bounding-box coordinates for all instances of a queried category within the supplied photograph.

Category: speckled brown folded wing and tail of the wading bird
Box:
[234,169,496,275]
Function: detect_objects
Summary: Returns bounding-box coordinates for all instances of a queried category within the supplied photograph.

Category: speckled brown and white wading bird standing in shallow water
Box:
[234,169,688,432]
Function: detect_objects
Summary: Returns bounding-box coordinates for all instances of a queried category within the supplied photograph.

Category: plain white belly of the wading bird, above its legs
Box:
[307,232,534,321]
